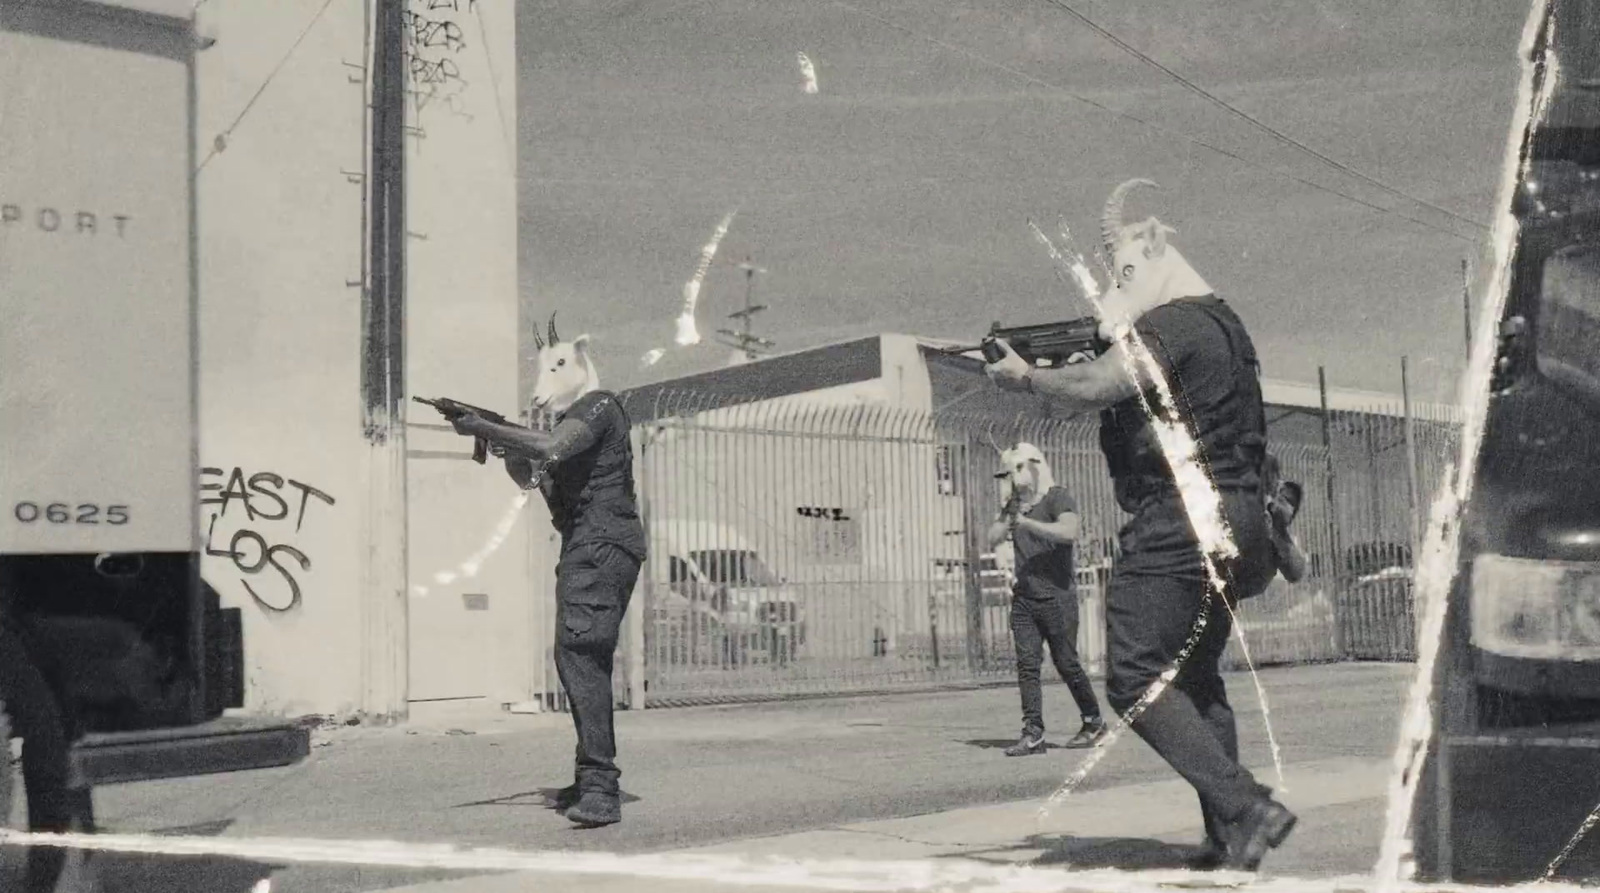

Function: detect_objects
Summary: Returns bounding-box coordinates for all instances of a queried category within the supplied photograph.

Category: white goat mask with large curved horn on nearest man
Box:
[1101,179,1213,338]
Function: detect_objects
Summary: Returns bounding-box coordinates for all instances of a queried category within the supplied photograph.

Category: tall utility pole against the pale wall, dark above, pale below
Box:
[360,0,410,723]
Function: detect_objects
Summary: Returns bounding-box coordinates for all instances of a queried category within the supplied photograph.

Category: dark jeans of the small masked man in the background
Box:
[1011,594,1099,736]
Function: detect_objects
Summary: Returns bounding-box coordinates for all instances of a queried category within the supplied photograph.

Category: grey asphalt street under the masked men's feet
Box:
[0,664,1411,893]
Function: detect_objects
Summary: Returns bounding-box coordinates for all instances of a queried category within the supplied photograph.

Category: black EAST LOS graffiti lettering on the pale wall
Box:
[200,467,334,613]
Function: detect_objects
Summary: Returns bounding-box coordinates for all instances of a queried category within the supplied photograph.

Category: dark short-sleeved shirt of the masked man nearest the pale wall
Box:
[539,390,646,560]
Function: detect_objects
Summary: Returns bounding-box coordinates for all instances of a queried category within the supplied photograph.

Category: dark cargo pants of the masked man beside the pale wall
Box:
[555,543,640,795]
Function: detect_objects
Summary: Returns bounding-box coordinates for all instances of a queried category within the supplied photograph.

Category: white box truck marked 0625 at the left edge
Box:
[0,0,309,851]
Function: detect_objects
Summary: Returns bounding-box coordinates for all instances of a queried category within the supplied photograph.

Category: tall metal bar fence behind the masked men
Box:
[572,394,1456,706]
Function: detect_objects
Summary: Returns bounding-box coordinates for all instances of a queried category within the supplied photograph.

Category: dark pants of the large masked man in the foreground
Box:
[1106,490,1274,840]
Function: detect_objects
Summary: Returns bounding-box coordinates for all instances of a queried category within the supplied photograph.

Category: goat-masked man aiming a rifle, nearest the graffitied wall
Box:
[451,317,646,827]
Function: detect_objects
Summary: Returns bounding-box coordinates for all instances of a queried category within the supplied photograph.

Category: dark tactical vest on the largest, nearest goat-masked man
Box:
[1099,296,1267,514]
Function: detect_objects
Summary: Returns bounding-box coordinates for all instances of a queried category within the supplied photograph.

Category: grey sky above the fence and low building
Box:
[517,0,1528,400]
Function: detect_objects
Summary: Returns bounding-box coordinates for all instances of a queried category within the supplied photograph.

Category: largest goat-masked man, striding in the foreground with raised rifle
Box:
[987,181,1296,871]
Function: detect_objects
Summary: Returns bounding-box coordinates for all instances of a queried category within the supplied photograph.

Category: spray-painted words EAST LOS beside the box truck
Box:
[200,466,334,613]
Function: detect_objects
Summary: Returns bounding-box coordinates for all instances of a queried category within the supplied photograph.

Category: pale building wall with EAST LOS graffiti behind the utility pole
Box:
[198,0,522,715]
